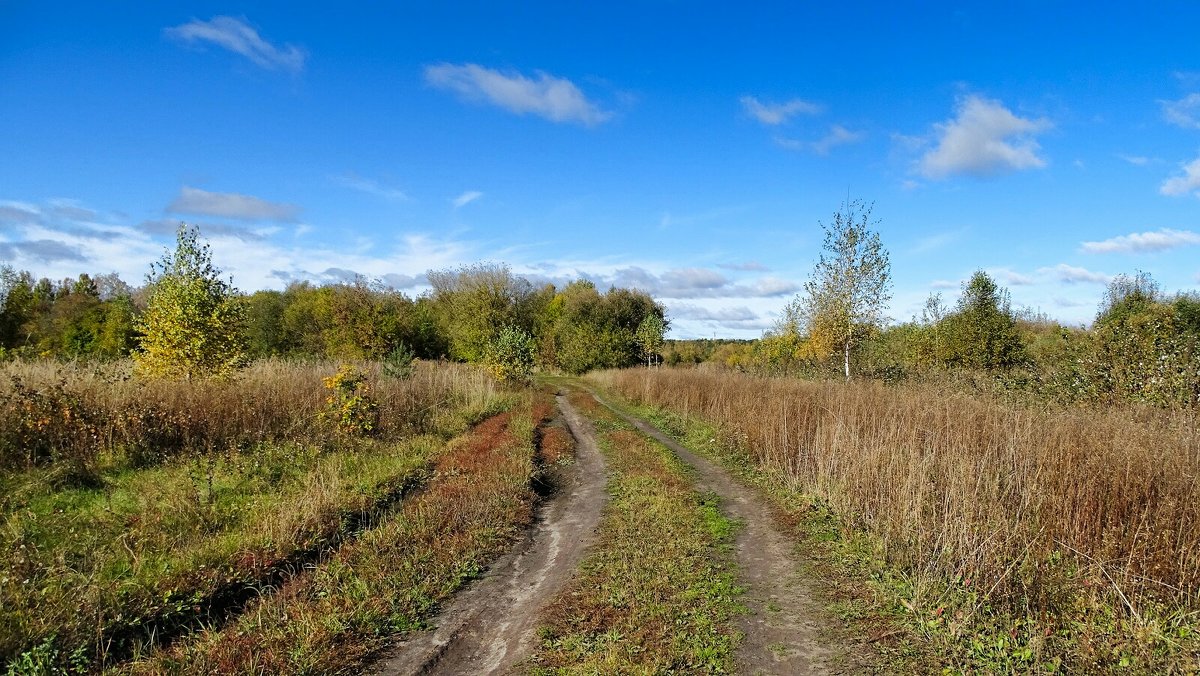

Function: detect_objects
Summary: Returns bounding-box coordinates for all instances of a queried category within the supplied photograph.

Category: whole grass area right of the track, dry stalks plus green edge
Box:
[594,371,1200,671]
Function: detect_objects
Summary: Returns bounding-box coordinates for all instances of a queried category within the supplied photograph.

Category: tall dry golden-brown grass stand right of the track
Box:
[590,370,1200,657]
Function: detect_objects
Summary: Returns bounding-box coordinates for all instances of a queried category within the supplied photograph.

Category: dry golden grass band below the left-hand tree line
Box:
[0,360,497,471]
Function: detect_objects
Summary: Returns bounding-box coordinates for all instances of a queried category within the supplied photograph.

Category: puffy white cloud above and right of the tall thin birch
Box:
[917,95,1051,179]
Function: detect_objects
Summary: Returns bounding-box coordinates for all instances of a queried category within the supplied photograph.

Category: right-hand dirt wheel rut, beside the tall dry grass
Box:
[593,395,860,675]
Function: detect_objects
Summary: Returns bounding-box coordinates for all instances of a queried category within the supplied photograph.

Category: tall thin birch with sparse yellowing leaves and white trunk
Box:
[803,199,892,382]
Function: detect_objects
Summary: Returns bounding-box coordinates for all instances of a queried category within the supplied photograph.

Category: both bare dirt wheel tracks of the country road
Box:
[377,395,860,675]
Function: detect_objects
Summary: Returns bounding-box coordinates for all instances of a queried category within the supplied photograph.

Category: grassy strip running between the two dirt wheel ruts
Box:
[530,393,740,674]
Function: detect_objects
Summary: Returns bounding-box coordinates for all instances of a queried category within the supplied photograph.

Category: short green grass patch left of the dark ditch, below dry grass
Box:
[0,437,442,662]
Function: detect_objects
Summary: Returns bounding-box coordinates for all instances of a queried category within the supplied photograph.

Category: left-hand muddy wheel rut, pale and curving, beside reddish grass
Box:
[376,395,607,675]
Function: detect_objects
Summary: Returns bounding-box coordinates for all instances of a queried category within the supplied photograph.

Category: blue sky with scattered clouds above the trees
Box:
[0,1,1200,337]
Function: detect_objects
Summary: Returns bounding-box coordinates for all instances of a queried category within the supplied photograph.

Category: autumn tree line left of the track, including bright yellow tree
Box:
[0,227,668,376]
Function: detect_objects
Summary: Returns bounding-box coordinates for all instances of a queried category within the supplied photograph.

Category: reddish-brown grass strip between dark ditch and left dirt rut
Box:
[112,389,556,674]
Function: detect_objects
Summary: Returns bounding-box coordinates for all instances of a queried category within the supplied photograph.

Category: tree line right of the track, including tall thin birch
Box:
[664,202,1200,408]
